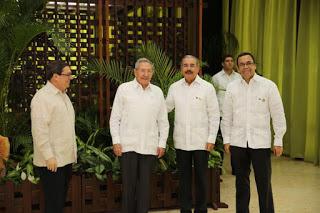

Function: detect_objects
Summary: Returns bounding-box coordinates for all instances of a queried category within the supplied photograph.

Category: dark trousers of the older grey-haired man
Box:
[120,152,156,213]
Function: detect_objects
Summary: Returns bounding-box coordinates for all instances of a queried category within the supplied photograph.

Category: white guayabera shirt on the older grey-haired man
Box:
[110,79,169,155]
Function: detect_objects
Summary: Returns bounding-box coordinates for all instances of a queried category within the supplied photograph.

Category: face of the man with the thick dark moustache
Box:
[181,57,200,85]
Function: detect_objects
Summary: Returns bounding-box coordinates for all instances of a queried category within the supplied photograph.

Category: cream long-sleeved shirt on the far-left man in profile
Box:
[31,81,77,167]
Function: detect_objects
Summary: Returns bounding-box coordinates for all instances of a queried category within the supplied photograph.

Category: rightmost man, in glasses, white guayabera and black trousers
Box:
[221,52,286,213]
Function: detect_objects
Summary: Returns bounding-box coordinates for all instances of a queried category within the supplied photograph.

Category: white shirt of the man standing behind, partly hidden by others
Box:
[212,69,241,116]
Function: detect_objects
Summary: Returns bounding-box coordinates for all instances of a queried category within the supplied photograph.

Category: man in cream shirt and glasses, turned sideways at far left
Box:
[31,61,77,213]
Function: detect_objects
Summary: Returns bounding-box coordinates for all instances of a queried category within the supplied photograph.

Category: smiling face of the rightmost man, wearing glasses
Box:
[237,55,256,83]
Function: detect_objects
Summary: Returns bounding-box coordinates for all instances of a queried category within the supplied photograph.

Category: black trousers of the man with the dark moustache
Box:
[176,149,208,213]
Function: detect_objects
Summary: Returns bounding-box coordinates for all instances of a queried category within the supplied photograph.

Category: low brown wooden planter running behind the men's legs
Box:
[0,169,227,213]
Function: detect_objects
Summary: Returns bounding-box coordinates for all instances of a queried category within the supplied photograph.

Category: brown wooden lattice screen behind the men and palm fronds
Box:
[9,0,201,123]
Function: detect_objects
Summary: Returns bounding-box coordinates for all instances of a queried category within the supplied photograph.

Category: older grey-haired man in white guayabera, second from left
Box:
[110,58,169,213]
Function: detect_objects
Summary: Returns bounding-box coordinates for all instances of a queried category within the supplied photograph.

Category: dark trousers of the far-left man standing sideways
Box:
[37,164,72,213]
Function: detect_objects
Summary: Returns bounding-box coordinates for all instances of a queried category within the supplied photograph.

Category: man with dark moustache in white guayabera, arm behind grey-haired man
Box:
[166,55,220,213]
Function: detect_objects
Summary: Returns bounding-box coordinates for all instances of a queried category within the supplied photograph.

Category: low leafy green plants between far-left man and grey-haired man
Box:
[73,108,120,181]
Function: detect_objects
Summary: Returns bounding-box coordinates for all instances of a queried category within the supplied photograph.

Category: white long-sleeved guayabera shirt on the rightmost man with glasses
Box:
[221,74,286,149]
